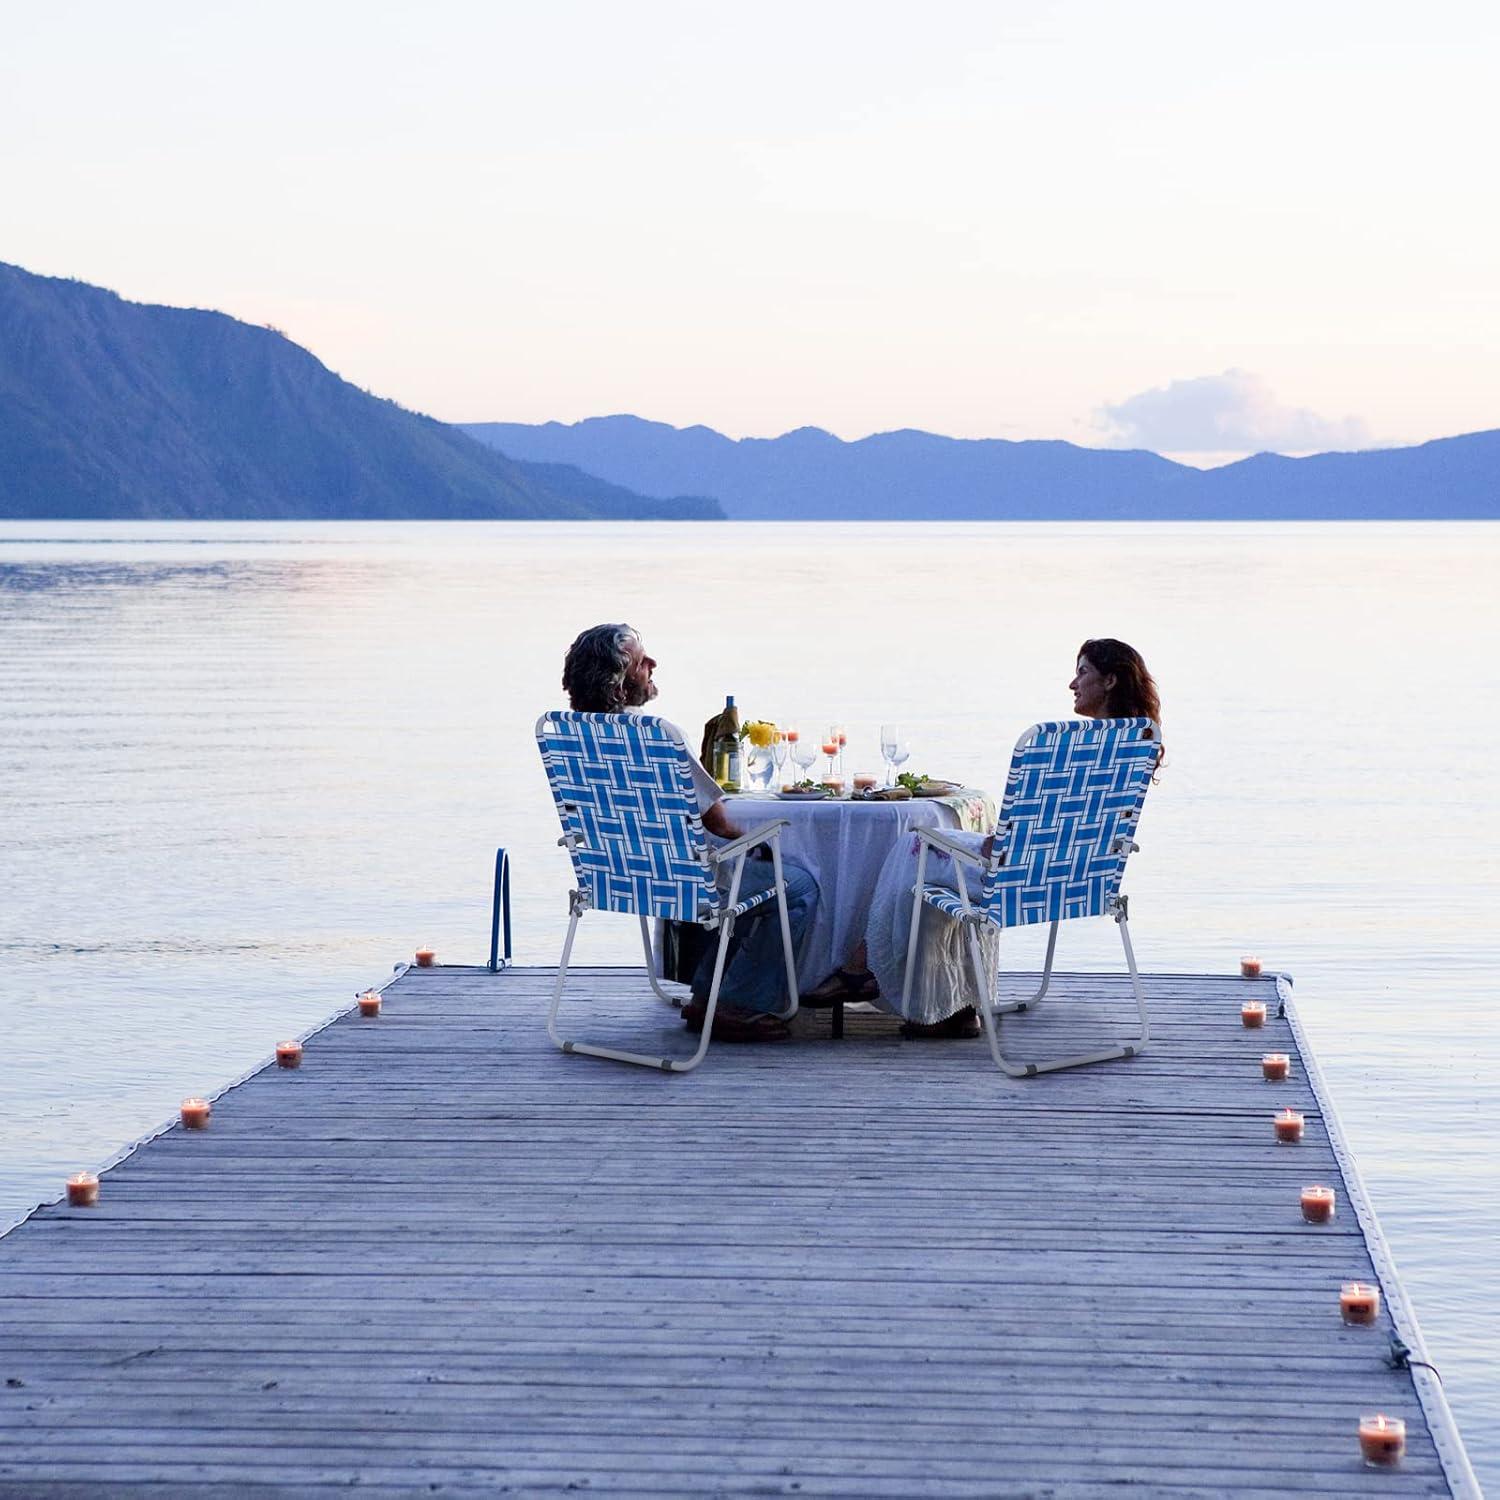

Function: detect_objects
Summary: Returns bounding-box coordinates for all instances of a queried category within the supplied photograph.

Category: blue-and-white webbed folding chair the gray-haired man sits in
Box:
[537,711,798,1073]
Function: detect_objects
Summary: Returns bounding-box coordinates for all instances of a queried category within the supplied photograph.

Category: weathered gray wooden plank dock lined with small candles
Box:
[0,968,1479,1500]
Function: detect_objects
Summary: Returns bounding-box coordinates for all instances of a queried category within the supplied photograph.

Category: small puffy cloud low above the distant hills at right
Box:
[1095,371,1374,453]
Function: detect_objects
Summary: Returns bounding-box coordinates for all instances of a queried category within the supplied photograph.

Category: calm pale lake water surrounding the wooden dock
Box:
[0,524,1500,1482]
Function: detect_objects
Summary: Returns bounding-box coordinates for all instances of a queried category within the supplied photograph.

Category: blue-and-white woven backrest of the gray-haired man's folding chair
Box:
[537,711,717,923]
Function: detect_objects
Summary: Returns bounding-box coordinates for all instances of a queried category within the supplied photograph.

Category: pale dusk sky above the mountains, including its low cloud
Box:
[0,0,1500,462]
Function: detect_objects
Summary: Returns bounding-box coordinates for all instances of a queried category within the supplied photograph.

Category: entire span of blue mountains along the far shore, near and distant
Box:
[0,264,1500,521]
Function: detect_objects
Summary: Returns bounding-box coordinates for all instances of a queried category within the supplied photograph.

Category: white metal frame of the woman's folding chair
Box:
[902,719,1161,1079]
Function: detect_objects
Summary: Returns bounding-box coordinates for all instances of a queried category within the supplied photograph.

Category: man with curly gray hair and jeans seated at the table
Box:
[563,626,818,1041]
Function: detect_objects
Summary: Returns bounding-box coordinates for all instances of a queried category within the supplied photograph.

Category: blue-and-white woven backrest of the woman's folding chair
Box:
[980,719,1161,927]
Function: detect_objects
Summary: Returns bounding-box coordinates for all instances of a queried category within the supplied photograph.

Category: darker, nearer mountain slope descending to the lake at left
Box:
[0,264,723,521]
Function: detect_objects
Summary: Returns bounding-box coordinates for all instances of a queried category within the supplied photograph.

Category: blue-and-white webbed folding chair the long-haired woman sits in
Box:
[903,719,1161,1079]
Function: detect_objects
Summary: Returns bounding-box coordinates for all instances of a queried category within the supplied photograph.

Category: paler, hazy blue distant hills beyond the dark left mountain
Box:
[464,417,1500,521]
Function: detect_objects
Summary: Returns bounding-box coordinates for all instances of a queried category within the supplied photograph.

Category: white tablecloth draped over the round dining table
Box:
[725,792,995,989]
